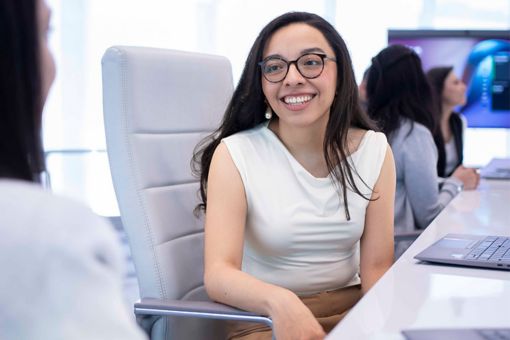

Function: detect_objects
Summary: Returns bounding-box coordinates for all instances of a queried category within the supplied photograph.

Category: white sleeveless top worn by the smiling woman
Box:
[223,123,388,295]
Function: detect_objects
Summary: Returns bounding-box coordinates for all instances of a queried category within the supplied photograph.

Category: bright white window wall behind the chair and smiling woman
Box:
[44,0,510,215]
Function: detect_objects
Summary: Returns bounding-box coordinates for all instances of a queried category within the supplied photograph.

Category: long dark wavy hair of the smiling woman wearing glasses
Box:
[192,12,376,219]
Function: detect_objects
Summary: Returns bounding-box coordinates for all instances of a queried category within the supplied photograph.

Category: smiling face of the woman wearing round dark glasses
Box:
[261,23,337,127]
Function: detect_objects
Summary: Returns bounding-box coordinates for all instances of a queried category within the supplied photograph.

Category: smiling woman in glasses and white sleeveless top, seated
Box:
[195,12,395,340]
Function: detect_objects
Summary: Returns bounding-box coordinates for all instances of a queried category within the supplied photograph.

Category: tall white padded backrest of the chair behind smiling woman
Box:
[102,46,233,339]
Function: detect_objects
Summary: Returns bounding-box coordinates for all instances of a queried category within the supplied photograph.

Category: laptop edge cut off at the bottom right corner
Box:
[402,328,510,340]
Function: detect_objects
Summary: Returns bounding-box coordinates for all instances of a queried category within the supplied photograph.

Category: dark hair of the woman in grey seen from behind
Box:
[367,45,437,138]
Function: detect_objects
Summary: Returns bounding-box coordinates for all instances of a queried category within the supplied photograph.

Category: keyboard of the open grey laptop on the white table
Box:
[464,236,510,263]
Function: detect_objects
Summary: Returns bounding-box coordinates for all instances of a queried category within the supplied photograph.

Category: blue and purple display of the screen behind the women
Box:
[389,31,510,128]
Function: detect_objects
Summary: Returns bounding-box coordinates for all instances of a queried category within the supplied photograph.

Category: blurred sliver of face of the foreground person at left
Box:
[37,0,55,103]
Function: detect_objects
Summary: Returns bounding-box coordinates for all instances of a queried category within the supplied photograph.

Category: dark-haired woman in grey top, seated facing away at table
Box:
[367,45,470,247]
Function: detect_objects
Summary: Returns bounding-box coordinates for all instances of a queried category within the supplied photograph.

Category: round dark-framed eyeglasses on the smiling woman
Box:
[259,53,336,83]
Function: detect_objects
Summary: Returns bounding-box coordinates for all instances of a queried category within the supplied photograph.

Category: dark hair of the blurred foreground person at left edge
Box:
[0,0,44,181]
